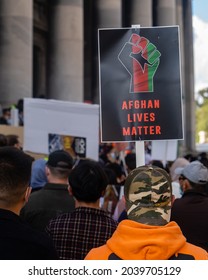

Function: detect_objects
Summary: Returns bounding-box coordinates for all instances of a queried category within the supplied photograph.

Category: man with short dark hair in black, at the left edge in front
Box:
[0,147,58,260]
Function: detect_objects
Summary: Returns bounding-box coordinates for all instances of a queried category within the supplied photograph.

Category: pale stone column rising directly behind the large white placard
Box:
[47,0,83,102]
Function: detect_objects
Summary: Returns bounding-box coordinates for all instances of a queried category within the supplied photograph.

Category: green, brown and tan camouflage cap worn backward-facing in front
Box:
[124,166,172,225]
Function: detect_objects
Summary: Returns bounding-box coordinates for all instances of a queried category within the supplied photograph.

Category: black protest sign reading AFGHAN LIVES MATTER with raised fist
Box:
[99,26,183,142]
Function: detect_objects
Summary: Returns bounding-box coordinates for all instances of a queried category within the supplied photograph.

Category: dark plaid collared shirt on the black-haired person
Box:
[46,207,117,260]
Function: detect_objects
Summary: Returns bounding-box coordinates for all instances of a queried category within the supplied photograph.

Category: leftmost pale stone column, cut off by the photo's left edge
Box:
[0,0,33,106]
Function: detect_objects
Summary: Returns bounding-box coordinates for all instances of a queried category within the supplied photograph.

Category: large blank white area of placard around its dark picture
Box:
[23,98,99,160]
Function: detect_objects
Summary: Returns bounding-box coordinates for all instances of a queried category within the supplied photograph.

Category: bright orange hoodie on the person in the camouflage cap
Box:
[85,220,208,260]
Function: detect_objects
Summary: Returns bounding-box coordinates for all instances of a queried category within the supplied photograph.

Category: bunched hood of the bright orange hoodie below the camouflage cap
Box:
[107,220,186,260]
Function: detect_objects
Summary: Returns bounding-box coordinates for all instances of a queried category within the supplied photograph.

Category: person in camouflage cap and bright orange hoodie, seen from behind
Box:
[85,165,208,260]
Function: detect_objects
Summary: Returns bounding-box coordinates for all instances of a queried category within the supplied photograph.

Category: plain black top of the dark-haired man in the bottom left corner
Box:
[0,209,58,260]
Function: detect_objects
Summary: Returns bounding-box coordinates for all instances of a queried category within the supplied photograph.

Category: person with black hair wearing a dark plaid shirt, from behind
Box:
[46,159,117,260]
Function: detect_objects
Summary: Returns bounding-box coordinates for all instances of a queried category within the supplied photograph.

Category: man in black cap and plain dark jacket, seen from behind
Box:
[20,150,75,231]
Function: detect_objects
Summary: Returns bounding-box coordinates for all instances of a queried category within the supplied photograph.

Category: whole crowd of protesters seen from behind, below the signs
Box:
[0,137,208,260]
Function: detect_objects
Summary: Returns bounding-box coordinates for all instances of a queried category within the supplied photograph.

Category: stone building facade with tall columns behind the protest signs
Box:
[0,0,195,151]
